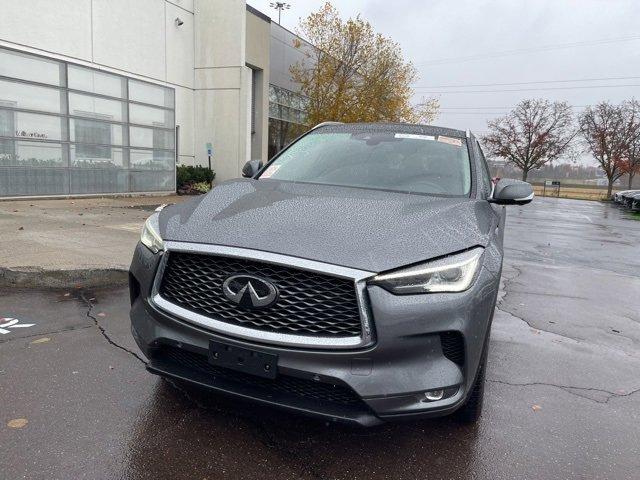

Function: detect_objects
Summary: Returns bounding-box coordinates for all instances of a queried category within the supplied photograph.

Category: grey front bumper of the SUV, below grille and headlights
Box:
[130,244,499,425]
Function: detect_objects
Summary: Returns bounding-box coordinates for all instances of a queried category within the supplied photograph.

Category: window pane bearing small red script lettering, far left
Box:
[0,110,63,140]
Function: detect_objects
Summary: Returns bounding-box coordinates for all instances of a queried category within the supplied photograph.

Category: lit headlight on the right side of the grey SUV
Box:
[369,247,484,295]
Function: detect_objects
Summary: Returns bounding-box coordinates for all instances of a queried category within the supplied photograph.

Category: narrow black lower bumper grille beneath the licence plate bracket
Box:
[154,346,363,406]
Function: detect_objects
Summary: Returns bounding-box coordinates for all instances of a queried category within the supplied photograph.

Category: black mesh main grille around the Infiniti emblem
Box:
[160,252,362,337]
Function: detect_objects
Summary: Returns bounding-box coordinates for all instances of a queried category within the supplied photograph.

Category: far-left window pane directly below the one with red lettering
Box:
[0,140,66,167]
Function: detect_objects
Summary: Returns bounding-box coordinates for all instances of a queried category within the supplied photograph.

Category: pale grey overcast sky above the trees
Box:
[247,0,640,163]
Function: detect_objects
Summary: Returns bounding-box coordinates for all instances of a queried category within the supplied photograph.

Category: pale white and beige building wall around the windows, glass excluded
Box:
[0,0,310,195]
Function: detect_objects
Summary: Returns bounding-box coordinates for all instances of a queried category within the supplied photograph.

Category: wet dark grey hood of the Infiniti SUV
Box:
[160,179,493,272]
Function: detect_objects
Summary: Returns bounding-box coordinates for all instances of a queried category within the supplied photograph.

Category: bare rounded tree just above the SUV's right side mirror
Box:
[482,99,577,180]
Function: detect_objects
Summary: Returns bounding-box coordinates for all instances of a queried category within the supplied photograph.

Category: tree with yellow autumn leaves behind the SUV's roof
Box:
[291,2,438,125]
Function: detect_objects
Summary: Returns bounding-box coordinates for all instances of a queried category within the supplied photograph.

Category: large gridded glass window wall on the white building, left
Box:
[0,56,178,196]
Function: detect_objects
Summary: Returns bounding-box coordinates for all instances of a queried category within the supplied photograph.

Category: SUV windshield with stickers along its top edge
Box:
[260,128,471,196]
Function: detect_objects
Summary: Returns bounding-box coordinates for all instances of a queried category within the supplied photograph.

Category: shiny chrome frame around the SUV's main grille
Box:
[150,241,375,349]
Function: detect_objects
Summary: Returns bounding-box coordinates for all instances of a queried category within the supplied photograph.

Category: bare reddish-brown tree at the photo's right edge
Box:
[579,102,640,196]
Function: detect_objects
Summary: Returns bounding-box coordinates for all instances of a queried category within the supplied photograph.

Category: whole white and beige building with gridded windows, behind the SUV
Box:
[0,0,306,197]
